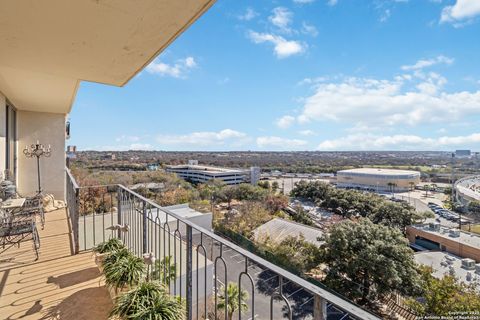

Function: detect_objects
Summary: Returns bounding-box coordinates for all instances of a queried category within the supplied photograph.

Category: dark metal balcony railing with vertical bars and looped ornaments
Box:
[66,169,378,320]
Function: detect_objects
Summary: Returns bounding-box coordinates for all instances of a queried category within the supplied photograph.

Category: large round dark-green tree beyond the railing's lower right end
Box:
[322,219,420,304]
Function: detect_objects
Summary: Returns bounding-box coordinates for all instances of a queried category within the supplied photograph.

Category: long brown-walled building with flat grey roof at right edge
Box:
[407,223,480,261]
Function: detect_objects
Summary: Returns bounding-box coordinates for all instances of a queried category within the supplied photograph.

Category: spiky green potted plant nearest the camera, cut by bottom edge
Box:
[110,281,184,320]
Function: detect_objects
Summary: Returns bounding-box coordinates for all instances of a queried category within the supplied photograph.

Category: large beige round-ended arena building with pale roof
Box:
[337,168,420,191]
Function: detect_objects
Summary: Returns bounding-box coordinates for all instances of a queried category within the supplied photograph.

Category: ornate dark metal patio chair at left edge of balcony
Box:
[0,215,40,260]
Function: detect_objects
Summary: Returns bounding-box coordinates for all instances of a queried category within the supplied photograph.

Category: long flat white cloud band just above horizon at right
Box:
[318,133,480,151]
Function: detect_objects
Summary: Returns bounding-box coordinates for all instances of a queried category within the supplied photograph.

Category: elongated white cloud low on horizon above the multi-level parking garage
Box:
[156,129,247,147]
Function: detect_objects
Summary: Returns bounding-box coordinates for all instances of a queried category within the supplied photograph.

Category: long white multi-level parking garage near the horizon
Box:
[165,160,260,185]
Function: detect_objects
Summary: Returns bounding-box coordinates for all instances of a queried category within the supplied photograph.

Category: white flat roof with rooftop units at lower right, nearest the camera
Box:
[414,251,480,284]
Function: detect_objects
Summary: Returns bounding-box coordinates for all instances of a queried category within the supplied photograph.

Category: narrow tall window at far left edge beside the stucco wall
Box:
[5,101,17,181]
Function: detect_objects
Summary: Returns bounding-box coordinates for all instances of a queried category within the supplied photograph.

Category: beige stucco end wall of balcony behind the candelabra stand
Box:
[17,110,65,200]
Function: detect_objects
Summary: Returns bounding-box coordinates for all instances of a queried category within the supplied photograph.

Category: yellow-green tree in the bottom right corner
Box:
[407,267,480,316]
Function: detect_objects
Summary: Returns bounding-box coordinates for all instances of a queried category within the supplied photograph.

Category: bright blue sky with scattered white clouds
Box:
[68,0,480,151]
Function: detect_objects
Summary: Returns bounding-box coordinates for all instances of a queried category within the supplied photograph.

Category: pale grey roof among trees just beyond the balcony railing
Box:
[253,218,323,245]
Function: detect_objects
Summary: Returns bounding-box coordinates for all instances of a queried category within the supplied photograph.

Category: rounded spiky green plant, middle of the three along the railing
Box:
[103,249,146,291]
